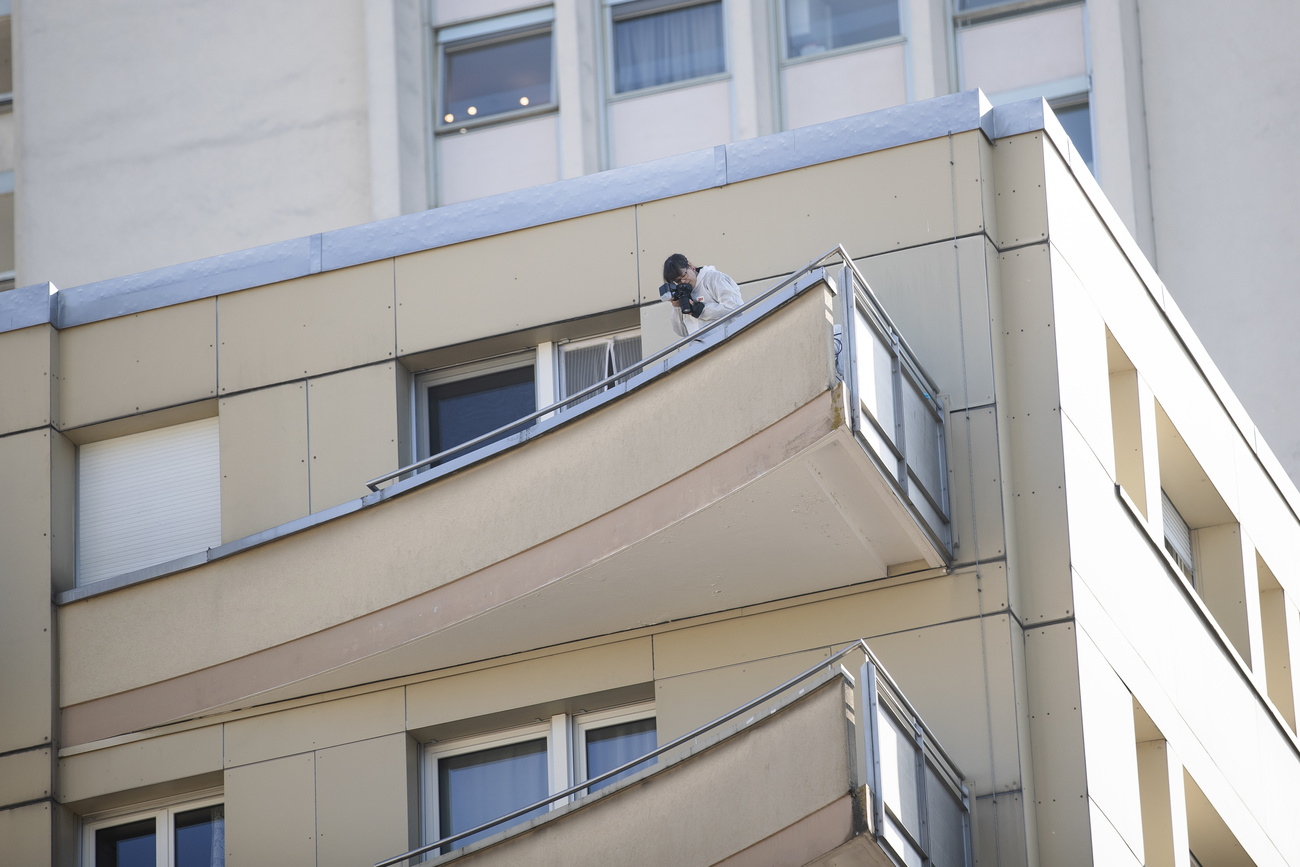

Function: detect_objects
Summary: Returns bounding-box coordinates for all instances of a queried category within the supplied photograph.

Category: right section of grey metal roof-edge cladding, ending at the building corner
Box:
[727,90,988,183]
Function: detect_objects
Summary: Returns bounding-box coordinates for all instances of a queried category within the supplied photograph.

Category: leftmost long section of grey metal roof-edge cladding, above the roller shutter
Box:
[56,238,312,328]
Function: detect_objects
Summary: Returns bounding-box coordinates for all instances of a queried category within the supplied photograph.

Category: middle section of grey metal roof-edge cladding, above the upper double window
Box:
[321,148,719,270]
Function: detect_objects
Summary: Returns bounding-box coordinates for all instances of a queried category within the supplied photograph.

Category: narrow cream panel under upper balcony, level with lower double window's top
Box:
[225,689,406,768]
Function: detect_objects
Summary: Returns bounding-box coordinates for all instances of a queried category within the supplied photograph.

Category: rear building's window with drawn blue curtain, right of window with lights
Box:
[612,0,727,94]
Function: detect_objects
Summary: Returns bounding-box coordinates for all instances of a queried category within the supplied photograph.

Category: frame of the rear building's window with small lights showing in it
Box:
[428,5,559,138]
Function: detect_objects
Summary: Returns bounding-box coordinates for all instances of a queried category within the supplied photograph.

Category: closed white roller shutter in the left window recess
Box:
[77,419,221,585]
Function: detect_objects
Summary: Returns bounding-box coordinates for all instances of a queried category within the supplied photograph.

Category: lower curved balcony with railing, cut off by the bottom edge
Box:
[376,641,972,867]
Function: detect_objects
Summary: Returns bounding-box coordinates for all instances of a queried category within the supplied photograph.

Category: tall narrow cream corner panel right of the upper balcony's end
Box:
[998,244,1071,623]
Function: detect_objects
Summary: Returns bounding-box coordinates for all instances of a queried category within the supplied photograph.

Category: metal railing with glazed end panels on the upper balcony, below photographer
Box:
[367,244,953,556]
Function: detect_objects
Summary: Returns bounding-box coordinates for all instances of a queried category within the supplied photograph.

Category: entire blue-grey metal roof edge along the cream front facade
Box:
[0,90,987,333]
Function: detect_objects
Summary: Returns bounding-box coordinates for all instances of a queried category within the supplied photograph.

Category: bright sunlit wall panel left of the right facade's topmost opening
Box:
[1050,246,1115,477]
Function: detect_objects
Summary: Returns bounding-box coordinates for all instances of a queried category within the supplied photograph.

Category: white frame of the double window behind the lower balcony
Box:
[420,699,658,851]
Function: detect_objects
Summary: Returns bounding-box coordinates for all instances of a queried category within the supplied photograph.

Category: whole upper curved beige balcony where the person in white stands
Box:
[60,247,950,744]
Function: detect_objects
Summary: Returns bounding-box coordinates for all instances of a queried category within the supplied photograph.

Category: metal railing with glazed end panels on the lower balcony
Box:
[374,638,974,867]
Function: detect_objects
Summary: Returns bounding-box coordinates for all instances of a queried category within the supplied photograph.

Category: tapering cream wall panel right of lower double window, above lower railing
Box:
[654,649,831,745]
